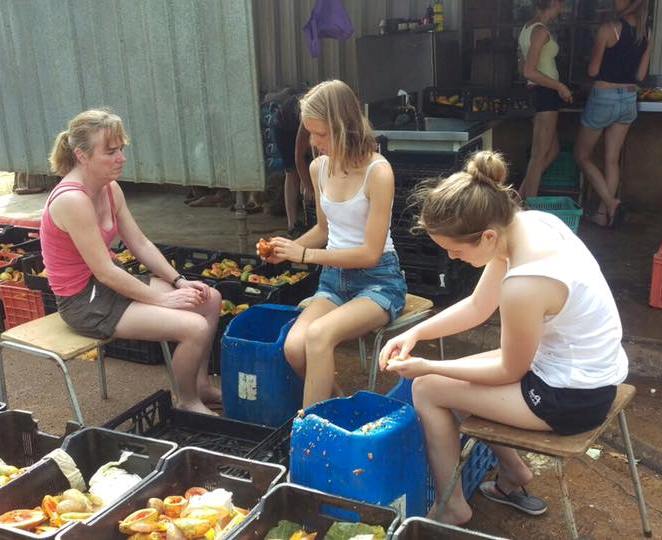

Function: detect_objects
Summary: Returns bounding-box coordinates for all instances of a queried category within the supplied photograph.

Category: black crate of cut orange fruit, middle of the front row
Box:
[56,447,285,540]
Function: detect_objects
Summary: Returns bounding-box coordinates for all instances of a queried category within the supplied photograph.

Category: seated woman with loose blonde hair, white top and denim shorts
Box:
[260,80,406,407]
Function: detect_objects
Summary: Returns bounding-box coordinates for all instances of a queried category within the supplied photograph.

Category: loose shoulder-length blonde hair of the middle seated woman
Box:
[300,80,377,172]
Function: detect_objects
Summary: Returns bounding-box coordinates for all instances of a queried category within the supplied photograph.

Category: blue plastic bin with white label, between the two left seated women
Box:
[221,304,303,427]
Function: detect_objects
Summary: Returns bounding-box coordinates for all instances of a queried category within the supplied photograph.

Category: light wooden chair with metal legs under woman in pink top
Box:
[0,313,176,425]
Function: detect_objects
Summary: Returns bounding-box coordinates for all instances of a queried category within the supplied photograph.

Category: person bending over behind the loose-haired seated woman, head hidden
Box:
[274,89,314,238]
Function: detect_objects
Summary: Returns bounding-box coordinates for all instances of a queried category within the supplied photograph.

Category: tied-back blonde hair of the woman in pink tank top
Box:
[48,109,129,176]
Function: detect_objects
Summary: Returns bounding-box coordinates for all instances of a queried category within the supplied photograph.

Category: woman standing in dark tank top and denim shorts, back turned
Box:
[575,0,652,227]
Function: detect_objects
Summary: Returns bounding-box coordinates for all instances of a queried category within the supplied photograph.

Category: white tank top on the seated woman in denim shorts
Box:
[317,156,394,253]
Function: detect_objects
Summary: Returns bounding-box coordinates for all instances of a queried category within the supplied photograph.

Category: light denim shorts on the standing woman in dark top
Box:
[581,88,637,129]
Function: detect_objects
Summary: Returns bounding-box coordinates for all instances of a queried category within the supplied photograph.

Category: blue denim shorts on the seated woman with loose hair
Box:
[315,251,407,321]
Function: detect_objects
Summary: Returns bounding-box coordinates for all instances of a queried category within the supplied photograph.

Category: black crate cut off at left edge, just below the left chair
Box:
[0,410,62,472]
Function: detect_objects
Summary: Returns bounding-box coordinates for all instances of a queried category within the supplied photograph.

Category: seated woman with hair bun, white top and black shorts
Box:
[380,151,628,524]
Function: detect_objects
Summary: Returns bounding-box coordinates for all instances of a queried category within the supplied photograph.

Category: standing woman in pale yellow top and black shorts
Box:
[518,0,572,199]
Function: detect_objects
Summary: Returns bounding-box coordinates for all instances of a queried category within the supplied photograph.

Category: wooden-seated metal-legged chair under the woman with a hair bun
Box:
[441,384,652,538]
